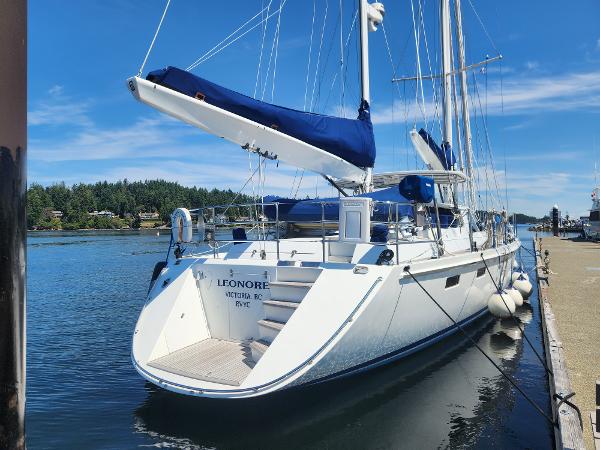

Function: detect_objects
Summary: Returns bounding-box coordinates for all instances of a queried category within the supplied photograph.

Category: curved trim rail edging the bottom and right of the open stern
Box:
[131,276,383,393]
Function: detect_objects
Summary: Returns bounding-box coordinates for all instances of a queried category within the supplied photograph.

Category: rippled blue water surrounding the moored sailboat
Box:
[26,227,552,449]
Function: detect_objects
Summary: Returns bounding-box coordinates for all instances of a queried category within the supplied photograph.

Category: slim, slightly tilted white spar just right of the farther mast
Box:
[454,0,475,210]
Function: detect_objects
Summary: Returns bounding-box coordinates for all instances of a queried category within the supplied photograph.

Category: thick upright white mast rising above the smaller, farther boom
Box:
[440,0,452,149]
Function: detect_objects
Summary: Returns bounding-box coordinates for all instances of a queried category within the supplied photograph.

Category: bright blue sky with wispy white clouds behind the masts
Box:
[28,0,600,217]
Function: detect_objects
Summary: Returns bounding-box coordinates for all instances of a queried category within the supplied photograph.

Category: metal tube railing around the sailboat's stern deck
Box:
[191,200,441,262]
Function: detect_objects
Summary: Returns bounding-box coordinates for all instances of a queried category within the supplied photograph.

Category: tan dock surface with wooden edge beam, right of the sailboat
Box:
[535,237,600,450]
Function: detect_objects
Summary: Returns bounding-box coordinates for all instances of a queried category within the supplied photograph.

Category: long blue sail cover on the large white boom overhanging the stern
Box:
[146,67,375,167]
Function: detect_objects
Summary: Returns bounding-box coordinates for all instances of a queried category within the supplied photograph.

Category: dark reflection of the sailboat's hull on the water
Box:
[135,304,544,448]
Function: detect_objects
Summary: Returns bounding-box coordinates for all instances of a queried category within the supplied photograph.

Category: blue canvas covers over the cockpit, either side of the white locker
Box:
[264,187,413,222]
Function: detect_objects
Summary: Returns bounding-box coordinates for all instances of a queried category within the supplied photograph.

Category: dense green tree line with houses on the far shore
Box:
[27,179,252,229]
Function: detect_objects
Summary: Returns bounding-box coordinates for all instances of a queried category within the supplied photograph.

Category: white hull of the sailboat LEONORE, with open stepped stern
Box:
[132,241,519,398]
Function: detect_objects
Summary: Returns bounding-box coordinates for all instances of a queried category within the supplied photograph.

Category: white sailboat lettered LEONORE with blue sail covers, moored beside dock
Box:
[127,0,520,398]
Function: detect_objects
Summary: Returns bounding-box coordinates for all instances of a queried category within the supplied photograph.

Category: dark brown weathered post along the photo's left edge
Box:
[0,0,27,450]
